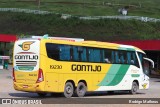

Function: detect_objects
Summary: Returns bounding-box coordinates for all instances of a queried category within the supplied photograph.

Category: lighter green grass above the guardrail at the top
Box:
[0,0,160,18]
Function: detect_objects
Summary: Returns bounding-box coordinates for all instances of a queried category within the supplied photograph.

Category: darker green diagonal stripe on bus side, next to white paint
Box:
[108,65,129,86]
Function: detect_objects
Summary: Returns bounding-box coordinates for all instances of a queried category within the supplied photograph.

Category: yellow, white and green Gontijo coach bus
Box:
[13,38,154,98]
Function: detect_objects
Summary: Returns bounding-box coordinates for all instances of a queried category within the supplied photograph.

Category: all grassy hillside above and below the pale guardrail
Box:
[0,0,160,41]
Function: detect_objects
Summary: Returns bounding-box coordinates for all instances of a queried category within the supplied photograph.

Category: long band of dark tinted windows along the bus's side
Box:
[46,43,139,67]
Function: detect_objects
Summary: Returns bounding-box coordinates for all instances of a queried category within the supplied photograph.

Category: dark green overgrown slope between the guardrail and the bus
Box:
[0,12,160,41]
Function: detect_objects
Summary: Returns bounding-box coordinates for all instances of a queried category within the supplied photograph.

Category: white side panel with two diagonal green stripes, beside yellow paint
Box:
[96,65,140,91]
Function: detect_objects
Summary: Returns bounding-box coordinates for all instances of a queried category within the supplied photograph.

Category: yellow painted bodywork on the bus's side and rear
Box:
[13,39,146,92]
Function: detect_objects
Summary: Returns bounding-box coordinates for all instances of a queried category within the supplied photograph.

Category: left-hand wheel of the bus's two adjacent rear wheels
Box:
[64,82,74,98]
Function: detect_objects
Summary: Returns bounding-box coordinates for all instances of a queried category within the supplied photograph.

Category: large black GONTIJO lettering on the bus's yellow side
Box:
[71,64,102,72]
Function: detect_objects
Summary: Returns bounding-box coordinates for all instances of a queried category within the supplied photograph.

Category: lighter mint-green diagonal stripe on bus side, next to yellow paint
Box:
[98,64,121,86]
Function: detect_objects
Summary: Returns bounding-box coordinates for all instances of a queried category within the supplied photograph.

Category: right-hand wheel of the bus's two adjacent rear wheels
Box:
[76,82,87,97]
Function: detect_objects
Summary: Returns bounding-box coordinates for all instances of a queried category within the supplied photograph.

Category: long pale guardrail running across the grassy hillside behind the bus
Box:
[0,8,160,22]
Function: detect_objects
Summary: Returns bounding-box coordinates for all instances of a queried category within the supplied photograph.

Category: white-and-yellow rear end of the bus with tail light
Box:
[13,40,44,92]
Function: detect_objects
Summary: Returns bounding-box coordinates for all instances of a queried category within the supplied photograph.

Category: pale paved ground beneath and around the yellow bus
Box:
[0,67,160,103]
